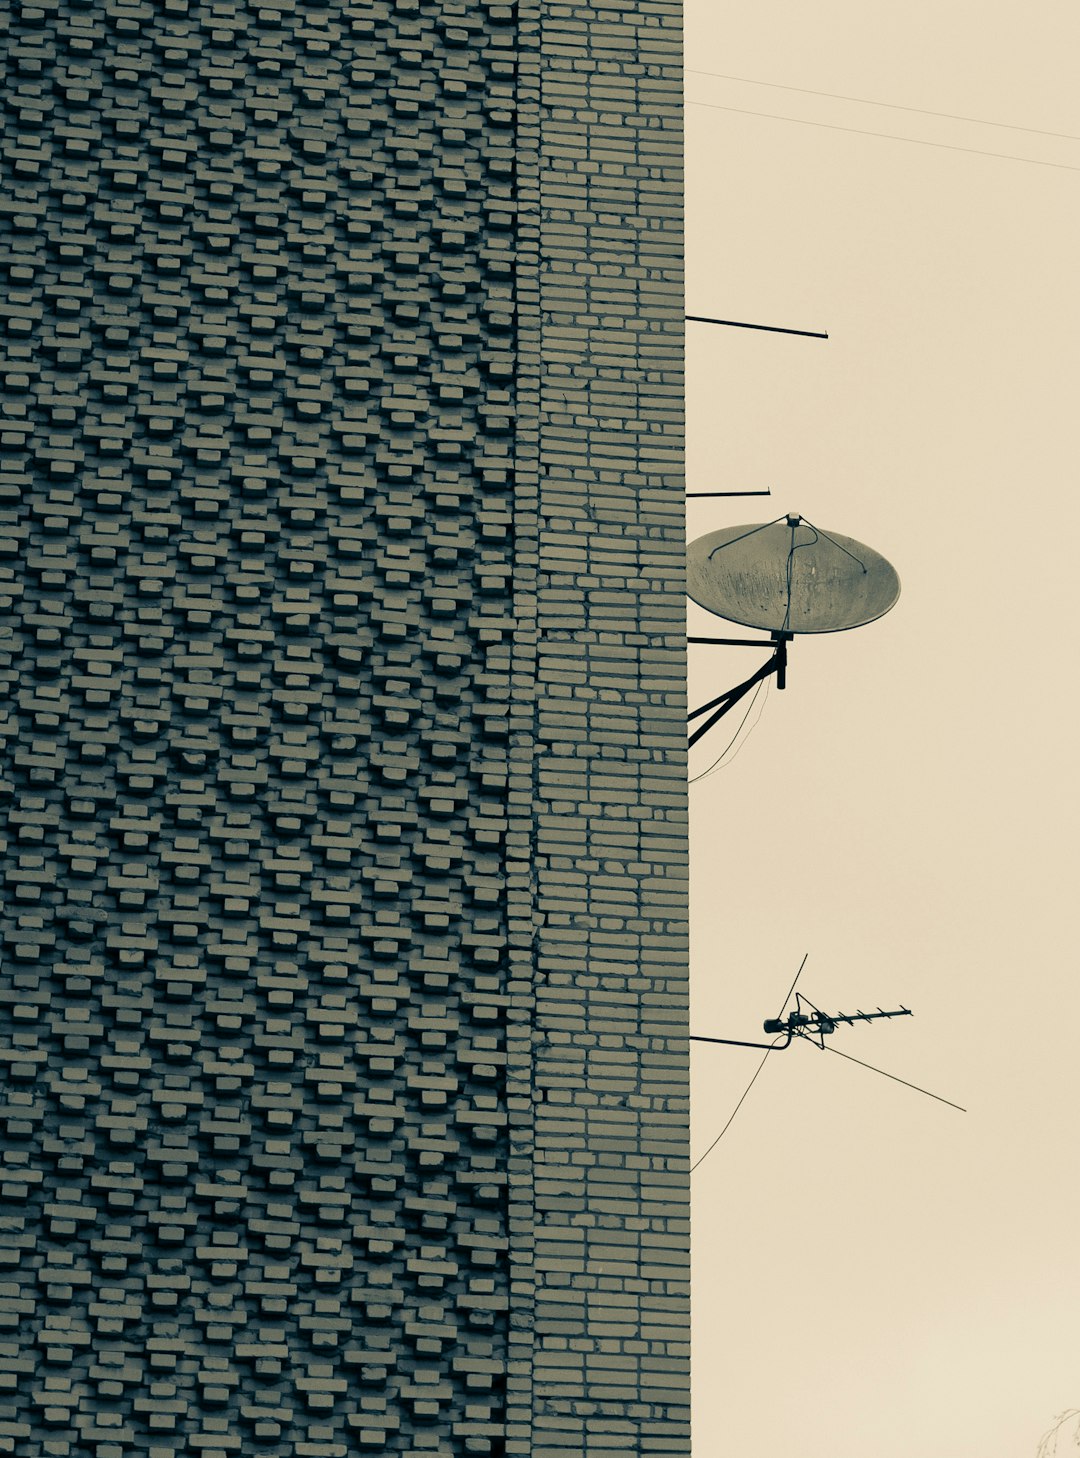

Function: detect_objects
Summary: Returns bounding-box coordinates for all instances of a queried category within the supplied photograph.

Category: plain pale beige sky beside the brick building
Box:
[686,0,1080,1458]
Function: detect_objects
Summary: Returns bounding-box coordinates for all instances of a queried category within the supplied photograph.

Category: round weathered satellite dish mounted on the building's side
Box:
[686,516,899,634]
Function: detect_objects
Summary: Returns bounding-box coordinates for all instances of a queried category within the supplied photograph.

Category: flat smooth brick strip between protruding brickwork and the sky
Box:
[512,0,689,1458]
